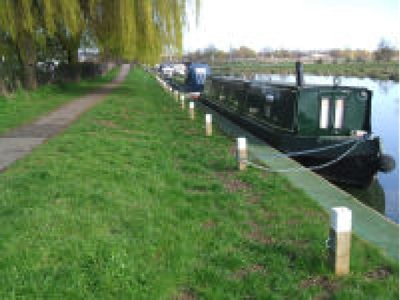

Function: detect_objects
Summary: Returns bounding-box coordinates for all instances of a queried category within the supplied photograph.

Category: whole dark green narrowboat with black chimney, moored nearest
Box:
[200,63,394,186]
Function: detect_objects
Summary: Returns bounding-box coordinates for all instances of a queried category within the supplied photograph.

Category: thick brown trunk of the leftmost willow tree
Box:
[18,32,38,90]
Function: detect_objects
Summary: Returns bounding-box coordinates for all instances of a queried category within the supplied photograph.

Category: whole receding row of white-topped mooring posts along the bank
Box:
[156,76,352,275]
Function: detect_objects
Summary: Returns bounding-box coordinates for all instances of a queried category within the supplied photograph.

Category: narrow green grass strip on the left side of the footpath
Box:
[0,68,118,134]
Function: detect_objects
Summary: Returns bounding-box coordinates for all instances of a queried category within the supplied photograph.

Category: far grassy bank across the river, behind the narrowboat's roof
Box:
[213,62,399,81]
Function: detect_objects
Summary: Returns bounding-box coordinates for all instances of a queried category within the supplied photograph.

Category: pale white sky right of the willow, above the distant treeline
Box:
[184,0,400,51]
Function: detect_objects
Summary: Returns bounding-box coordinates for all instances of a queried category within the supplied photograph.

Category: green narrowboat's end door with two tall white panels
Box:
[318,91,349,135]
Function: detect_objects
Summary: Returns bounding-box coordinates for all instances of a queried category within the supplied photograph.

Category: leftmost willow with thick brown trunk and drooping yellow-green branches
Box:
[0,0,81,89]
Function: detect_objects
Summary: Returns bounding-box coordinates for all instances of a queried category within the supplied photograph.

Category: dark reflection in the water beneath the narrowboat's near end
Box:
[340,179,385,215]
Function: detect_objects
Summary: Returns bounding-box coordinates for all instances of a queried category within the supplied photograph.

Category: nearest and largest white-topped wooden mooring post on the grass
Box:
[328,206,352,276]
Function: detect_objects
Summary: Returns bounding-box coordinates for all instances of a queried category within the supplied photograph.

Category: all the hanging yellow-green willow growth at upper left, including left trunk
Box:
[0,0,200,88]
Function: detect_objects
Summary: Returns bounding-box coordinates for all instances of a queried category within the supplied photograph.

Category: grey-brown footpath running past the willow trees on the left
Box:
[0,64,130,172]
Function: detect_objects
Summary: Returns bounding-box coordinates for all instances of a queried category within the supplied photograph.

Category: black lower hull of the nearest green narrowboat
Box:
[200,97,380,187]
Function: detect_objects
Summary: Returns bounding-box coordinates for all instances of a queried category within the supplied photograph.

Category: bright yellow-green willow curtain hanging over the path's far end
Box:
[86,0,199,63]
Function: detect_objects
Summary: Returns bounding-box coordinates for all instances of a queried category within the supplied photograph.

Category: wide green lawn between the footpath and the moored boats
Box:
[0,69,398,299]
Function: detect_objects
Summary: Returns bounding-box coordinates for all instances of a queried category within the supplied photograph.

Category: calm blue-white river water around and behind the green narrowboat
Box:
[255,74,399,223]
